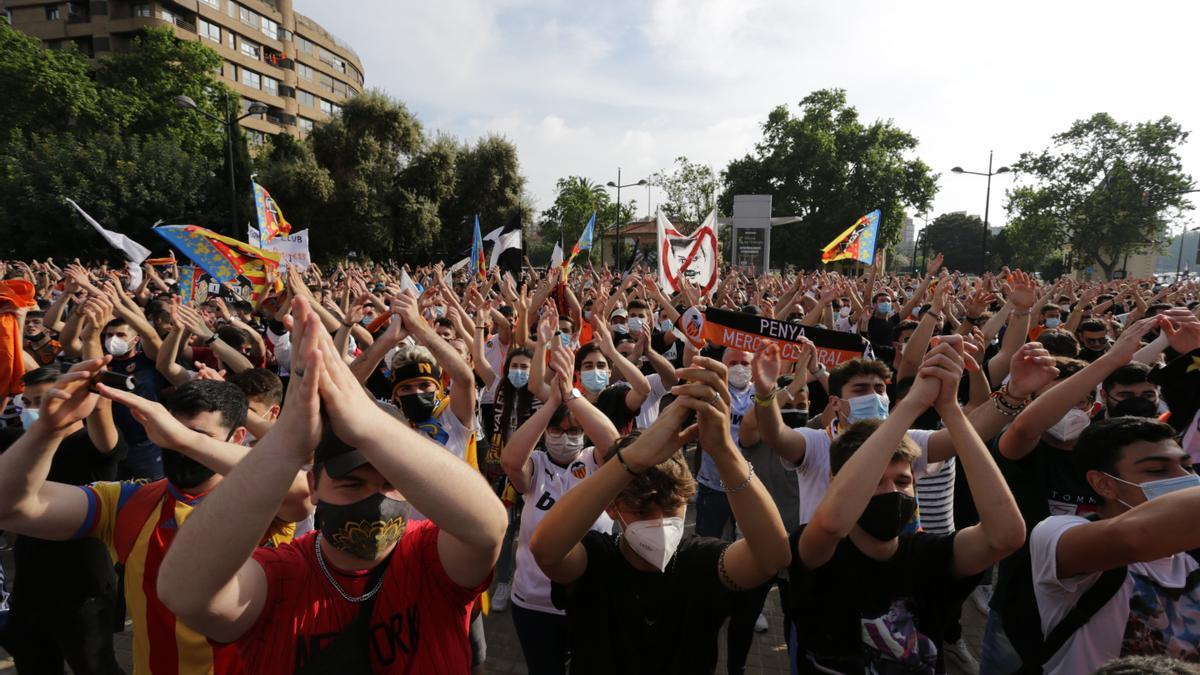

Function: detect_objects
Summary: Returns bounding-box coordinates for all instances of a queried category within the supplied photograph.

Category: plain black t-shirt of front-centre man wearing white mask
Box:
[552,532,734,675]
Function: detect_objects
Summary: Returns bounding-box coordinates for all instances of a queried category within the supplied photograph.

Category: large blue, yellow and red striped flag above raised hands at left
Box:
[154,225,283,299]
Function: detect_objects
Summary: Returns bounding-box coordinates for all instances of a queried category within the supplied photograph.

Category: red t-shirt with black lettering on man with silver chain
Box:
[235,520,491,675]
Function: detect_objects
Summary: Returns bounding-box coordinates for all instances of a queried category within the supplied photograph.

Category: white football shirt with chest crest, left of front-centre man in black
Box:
[512,447,612,615]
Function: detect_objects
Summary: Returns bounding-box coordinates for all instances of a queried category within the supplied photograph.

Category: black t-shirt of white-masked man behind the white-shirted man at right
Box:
[991,436,1100,651]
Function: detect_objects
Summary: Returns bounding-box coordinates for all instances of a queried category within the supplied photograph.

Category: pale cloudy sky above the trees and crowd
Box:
[295,0,1200,235]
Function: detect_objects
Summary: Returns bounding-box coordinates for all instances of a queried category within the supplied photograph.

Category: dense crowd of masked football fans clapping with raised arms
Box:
[0,249,1200,675]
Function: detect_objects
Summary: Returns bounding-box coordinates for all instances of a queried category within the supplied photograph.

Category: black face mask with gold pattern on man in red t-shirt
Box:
[316,492,410,560]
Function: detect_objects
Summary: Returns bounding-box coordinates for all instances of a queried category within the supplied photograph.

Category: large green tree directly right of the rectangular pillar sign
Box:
[719,89,937,268]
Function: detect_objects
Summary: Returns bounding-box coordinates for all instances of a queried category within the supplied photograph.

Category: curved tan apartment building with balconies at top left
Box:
[0,0,364,143]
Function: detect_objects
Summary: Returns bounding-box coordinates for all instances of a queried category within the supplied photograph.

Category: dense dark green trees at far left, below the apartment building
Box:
[0,22,236,258]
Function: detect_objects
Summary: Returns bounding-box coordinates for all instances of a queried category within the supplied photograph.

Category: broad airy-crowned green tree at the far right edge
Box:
[1007,113,1192,277]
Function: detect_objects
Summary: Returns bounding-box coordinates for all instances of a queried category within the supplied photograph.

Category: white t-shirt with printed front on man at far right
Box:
[1030,515,1200,675]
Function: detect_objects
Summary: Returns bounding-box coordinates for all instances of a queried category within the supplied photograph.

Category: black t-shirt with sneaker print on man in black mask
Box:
[787,526,974,673]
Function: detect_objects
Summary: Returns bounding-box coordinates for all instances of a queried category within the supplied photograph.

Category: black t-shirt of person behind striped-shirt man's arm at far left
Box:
[0,429,127,595]
